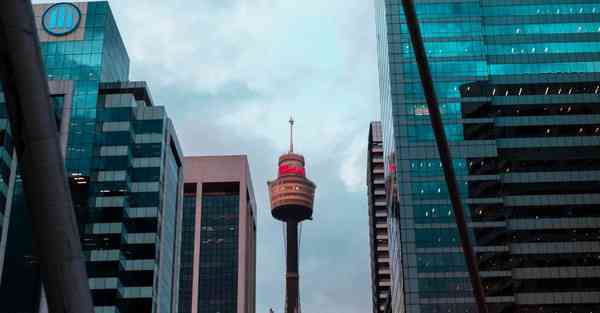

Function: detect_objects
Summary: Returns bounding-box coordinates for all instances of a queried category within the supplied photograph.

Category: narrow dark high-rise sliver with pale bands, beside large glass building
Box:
[367,122,391,313]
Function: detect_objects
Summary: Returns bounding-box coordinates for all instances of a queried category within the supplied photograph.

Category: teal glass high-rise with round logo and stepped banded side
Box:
[0,1,183,313]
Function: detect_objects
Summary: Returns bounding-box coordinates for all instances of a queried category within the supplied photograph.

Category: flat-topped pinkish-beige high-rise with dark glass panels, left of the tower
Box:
[179,155,256,313]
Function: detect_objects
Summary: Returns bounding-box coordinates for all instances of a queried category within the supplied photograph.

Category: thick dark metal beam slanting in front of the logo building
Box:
[0,0,93,313]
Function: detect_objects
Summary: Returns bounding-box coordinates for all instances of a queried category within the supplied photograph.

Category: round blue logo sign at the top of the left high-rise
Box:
[42,3,81,36]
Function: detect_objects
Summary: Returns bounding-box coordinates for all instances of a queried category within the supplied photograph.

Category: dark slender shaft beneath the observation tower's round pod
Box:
[285,220,300,313]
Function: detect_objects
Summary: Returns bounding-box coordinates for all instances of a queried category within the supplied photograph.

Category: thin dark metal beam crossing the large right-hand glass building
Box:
[402,0,488,313]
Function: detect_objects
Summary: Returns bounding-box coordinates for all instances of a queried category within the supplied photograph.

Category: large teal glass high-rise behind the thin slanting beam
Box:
[375,0,600,313]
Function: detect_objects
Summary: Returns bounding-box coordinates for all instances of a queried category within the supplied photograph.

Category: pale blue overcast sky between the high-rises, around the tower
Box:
[35,0,379,313]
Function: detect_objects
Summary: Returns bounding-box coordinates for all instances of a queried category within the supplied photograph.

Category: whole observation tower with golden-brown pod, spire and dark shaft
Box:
[267,118,316,313]
